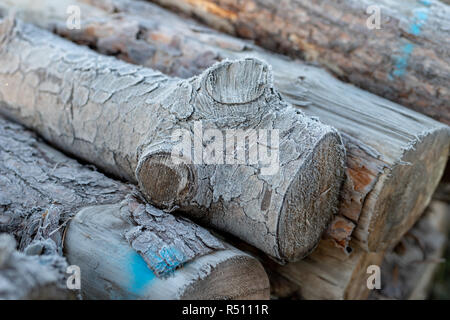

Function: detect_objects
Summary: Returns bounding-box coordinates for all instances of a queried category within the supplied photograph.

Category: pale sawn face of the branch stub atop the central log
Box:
[204,58,272,104]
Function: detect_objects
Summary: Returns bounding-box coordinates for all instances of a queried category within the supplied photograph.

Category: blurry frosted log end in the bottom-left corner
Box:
[0,233,75,300]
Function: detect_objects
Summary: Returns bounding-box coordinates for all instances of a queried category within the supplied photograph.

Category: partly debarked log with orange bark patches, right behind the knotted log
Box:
[3,0,449,252]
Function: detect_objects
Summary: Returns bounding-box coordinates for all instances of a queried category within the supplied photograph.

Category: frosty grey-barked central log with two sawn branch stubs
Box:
[0,15,345,261]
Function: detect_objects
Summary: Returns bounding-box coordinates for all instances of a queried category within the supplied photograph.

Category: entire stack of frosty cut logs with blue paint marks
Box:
[0,0,450,299]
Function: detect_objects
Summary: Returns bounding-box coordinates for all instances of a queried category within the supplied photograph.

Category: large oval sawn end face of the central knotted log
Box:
[278,131,345,261]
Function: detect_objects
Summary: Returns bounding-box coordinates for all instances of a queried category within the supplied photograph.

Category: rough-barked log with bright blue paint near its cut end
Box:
[0,118,269,299]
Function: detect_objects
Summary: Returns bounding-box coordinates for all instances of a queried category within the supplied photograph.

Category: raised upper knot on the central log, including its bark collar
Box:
[192,58,284,128]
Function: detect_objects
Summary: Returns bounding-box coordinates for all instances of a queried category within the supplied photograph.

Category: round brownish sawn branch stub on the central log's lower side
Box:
[136,153,196,208]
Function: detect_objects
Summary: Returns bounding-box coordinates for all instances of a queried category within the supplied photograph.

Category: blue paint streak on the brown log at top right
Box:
[388,0,431,80]
